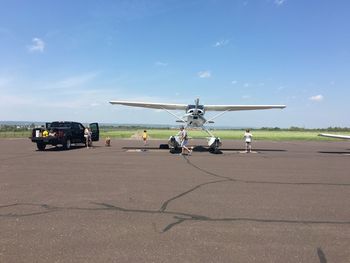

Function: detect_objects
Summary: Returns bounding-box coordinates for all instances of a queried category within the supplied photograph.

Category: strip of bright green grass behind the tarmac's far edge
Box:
[0,127,347,141]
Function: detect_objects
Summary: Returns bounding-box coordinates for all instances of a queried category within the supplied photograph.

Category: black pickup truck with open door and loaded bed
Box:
[29,121,100,151]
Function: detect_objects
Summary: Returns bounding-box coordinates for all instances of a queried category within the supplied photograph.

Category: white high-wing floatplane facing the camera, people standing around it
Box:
[109,98,286,152]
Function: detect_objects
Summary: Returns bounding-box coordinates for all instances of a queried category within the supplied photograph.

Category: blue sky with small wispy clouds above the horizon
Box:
[0,0,350,128]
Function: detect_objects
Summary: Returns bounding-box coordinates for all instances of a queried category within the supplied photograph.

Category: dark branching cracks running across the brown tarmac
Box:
[0,156,350,233]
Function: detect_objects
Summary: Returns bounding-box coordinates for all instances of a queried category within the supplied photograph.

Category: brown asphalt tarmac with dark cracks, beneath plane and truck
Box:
[0,139,350,263]
